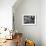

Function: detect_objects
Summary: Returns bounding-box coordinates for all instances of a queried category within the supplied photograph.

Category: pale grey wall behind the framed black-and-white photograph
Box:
[13,0,41,46]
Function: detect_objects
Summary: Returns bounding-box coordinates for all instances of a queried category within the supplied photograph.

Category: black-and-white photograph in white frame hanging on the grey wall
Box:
[22,15,36,25]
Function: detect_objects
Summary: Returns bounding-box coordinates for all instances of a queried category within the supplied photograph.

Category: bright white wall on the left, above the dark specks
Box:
[0,0,16,29]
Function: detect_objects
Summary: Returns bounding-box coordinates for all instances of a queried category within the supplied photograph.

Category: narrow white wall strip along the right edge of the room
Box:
[41,0,46,46]
